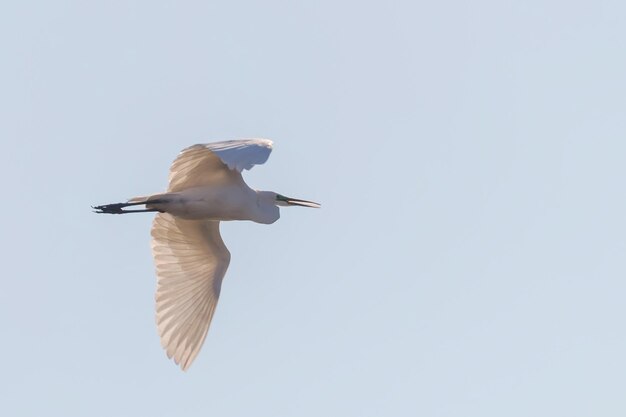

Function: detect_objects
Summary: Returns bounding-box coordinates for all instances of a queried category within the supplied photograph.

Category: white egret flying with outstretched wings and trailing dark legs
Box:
[93,139,320,370]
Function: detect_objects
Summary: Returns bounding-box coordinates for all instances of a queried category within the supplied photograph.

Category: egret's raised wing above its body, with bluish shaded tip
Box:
[168,139,272,192]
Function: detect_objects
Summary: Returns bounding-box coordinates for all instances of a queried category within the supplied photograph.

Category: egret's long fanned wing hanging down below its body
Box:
[152,213,230,370]
